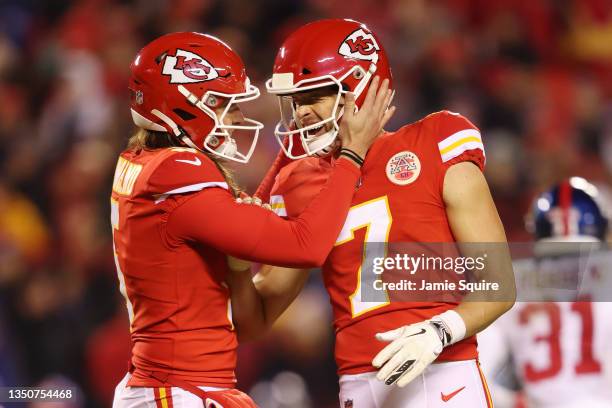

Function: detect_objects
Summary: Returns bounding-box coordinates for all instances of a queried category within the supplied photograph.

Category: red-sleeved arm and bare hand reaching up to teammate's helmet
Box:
[167,77,394,267]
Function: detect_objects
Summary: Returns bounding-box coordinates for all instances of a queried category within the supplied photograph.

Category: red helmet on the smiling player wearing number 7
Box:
[266,19,393,159]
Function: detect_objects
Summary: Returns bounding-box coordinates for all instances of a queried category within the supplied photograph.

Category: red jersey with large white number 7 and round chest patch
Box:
[260,111,485,374]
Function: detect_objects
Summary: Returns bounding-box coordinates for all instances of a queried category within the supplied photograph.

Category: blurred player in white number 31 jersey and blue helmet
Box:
[478,177,612,408]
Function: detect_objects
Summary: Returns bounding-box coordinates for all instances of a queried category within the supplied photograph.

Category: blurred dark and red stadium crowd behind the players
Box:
[0,0,612,407]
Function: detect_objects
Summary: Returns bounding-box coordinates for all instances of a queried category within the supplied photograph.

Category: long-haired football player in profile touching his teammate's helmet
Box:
[111,33,388,408]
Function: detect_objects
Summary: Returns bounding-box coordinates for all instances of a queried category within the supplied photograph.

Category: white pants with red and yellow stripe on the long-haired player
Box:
[113,373,230,408]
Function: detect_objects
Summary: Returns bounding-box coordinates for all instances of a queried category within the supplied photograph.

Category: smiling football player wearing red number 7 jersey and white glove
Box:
[230,19,515,408]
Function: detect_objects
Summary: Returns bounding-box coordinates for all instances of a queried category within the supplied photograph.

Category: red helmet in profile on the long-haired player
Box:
[129,33,263,163]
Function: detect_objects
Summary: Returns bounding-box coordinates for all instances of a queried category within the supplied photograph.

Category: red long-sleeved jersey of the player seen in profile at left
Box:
[111,148,359,387]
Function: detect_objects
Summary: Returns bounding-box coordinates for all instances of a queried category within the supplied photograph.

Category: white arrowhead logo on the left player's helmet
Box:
[162,49,219,84]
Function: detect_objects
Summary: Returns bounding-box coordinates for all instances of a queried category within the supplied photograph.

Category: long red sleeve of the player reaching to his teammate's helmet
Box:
[166,160,360,267]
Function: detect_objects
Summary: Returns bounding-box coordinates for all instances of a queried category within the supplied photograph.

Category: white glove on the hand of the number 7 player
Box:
[372,320,444,387]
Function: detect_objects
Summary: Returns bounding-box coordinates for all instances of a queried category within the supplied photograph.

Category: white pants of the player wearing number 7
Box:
[340,360,493,408]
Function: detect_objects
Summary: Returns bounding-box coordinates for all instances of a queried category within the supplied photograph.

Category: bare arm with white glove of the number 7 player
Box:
[372,162,516,387]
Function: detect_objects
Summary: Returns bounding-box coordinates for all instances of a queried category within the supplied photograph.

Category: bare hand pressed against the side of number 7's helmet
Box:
[338,76,395,158]
